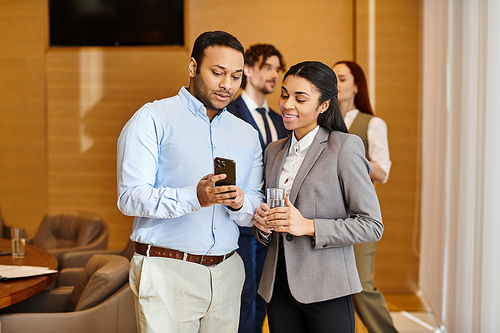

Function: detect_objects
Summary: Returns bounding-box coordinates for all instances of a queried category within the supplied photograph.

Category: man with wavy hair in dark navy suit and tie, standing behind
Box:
[227,44,287,333]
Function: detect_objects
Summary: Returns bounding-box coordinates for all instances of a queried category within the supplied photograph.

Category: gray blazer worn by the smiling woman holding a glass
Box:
[254,127,384,303]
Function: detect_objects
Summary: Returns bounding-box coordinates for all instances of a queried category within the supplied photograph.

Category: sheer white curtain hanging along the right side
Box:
[420,0,500,332]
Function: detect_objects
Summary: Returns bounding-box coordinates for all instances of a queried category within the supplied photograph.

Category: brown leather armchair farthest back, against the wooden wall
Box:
[31,212,109,263]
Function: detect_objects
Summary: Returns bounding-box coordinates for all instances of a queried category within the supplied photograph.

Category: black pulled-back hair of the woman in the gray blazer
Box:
[283,61,348,133]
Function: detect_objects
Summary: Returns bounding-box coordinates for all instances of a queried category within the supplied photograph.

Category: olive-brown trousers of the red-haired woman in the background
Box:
[352,242,397,333]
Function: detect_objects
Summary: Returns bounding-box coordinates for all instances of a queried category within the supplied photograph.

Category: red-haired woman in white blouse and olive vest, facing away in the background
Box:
[333,60,397,333]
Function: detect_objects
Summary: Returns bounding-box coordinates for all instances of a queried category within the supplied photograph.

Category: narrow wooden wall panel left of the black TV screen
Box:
[0,0,47,235]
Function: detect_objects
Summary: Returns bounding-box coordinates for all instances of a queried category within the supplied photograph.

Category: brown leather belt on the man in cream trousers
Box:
[135,242,235,266]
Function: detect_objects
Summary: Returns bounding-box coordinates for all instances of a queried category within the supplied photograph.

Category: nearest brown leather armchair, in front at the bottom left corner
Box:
[0,255,137,333]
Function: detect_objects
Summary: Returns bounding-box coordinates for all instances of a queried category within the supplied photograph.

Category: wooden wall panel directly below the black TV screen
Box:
[47,47,188,248]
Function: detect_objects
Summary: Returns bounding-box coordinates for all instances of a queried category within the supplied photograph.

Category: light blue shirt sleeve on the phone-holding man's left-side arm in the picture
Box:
[117,104,201,218]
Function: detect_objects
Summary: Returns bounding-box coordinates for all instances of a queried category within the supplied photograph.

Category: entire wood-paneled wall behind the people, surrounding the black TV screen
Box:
[0,0,420,292]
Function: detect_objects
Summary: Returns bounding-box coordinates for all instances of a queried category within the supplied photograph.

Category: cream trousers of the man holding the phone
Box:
[130,253,245,333]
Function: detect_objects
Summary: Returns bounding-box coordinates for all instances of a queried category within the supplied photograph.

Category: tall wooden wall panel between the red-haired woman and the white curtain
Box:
[356,0,421,293]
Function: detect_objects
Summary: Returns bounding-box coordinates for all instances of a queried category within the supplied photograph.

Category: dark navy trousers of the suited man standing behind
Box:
[236,228,267,333]
